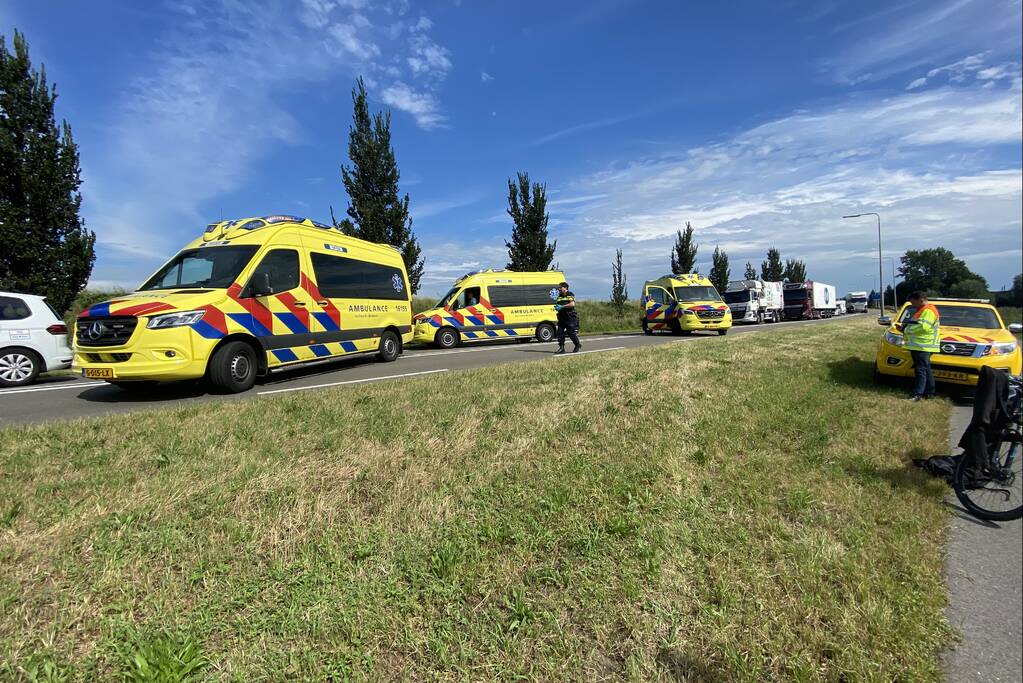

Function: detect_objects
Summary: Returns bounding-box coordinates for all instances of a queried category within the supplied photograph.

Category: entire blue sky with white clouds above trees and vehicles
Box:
[0,0,1023,298]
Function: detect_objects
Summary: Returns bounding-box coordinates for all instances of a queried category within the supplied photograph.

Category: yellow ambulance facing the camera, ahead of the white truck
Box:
[642,273,731,334]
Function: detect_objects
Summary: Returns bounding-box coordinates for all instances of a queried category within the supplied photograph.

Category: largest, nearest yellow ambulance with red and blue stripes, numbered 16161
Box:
[74,216,412,393]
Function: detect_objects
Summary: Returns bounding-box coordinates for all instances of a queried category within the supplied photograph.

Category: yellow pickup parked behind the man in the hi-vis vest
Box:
[874,299,1023,385]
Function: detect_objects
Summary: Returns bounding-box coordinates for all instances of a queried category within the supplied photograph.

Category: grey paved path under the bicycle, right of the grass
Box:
[941,406,1023,683]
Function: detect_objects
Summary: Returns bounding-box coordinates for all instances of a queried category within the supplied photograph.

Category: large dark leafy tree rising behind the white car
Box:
[0,31,96,314]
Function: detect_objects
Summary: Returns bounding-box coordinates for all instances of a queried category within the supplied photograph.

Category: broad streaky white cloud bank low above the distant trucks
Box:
[527,80,1023,297]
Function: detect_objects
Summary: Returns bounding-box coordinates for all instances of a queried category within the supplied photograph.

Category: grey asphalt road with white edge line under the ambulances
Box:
[0,318,842,428]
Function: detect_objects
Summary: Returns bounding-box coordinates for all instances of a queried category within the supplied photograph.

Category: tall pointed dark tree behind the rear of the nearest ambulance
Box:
[338,78,426,293]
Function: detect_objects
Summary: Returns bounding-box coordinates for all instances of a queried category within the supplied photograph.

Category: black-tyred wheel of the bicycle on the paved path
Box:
[952,435,1023,521]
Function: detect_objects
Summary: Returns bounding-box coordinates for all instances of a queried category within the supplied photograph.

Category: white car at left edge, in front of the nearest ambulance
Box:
[0,291,72,386]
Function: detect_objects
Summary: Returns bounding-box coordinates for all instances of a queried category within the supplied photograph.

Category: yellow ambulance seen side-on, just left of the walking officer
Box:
[413,269,565,349]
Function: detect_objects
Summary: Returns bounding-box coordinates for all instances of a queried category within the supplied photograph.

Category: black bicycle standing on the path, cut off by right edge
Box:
[952,376,1023,521]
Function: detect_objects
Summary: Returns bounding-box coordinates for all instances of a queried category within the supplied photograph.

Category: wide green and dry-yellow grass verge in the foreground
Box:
[0,317,950,681]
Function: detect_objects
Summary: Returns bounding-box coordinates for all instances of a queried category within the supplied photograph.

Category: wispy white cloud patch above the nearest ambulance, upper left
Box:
[79,0,456,284]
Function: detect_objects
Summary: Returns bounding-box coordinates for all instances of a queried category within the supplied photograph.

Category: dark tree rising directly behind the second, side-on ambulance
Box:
[504,172,558,271]
